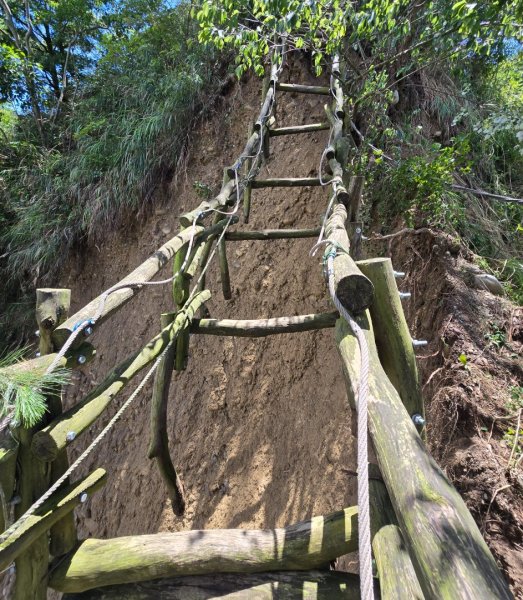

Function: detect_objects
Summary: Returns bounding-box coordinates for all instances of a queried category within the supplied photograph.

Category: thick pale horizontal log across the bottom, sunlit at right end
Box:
[51,507,357,592]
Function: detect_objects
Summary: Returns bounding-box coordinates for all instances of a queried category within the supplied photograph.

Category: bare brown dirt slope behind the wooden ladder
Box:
[53,59,523,593]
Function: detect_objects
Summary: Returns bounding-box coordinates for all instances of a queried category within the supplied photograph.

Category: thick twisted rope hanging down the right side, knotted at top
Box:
[323,246,374,600]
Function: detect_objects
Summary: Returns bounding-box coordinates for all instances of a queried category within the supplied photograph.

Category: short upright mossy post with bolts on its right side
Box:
[356,258,425,416]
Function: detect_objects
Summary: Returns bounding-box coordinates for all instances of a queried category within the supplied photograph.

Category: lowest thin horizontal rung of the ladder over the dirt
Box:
[191,312,339,337]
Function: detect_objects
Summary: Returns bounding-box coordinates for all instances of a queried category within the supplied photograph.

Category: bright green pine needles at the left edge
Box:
[0,350,69,427]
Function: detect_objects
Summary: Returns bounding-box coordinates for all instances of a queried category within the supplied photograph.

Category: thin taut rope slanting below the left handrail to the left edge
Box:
[0,335,173,544]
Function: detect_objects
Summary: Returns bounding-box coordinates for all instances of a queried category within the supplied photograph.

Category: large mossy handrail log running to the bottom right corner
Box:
[336,313,511,600]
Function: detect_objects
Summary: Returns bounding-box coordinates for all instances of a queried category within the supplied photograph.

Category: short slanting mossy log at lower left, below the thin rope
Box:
[0,469,106,572]
